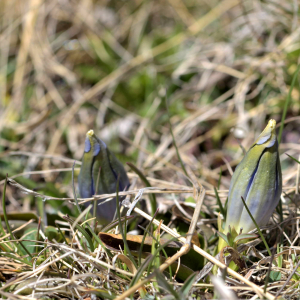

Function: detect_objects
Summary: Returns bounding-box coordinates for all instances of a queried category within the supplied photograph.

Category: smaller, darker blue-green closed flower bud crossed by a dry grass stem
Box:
[78,130,129,225]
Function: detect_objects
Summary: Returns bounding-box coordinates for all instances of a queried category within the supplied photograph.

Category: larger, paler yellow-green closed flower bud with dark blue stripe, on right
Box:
[224,120,282,233]
